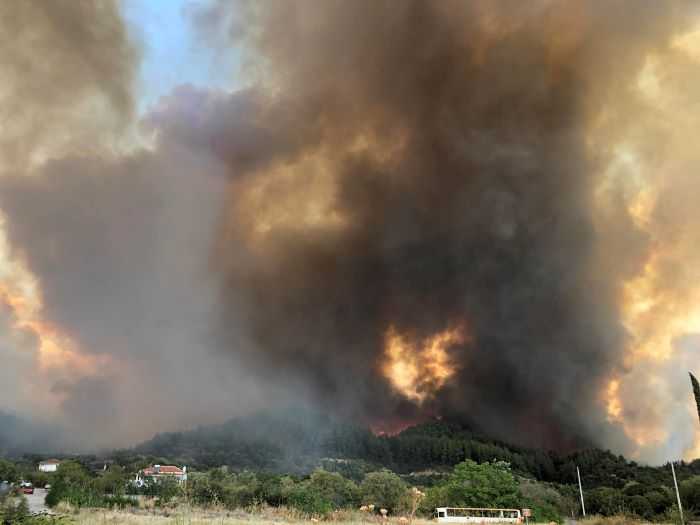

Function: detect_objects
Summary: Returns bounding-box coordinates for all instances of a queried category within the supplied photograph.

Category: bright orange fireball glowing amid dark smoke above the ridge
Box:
[382,325,468,404]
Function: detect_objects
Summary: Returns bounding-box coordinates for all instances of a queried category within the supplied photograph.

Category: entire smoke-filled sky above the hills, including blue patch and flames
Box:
[0,0,700,463]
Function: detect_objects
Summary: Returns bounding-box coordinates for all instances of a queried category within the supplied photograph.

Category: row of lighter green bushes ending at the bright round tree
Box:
[2,461,560,520]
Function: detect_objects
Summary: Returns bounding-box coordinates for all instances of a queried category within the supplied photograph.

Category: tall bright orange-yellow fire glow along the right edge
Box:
[600,23,700,458]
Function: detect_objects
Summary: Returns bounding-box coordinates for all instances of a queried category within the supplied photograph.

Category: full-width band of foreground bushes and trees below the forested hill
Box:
[0,454,684,523]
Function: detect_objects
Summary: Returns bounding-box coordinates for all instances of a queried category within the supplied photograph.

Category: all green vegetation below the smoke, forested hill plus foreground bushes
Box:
[0,412,700,522]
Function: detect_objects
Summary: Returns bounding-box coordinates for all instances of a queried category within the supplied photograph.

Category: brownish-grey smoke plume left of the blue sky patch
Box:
[0,0,139,171]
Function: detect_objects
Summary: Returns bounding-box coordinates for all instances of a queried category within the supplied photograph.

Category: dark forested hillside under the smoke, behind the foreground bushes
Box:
[130,410,700,488]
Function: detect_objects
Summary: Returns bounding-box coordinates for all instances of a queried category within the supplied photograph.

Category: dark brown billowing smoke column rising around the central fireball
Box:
[198,1,700,448]
